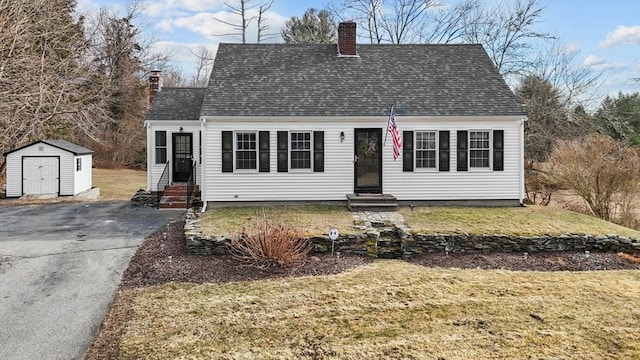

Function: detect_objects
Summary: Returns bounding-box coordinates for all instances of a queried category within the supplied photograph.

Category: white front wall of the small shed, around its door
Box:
[6,143,75,197]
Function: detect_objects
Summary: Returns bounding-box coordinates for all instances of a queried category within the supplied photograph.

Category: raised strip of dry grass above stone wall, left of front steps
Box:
[201,205,354,236]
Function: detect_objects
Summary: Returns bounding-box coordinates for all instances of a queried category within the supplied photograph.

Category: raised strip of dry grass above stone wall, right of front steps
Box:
[400,206,640,238]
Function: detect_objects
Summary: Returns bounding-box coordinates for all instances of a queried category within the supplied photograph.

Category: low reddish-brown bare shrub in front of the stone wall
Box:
[227,218,311,268]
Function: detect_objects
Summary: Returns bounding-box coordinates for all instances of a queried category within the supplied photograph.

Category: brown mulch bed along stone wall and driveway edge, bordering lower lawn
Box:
[85,221,640,360]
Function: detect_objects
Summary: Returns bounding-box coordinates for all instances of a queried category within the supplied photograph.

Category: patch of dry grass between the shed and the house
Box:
[93,169,147,200]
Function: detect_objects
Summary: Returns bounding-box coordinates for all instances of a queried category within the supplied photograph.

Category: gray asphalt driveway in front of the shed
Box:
[0,202,183,360]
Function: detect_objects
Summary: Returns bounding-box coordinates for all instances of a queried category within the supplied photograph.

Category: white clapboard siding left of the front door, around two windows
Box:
[205,122,353,201]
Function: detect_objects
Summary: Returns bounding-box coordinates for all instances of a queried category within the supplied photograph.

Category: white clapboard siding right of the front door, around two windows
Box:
[382,118,522,200]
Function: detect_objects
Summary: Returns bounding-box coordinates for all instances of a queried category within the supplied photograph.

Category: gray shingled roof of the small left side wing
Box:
[145,88,207,120]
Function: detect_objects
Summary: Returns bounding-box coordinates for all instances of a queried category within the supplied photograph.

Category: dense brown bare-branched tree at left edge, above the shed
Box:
[0,0,108,174]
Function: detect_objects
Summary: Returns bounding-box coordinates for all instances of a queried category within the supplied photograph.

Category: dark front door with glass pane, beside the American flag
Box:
[354,129,382,194]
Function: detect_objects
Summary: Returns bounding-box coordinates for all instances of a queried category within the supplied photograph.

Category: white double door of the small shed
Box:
[22,157,60,195]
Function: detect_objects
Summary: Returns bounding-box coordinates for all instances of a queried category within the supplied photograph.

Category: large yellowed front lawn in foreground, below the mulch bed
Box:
[119,261,640,359]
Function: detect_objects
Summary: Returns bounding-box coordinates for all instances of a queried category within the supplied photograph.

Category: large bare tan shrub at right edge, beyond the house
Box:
[549,135,640,226]
